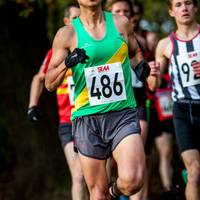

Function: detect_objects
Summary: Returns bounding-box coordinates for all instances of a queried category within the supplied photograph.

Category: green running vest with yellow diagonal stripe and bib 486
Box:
[72,12,136,120]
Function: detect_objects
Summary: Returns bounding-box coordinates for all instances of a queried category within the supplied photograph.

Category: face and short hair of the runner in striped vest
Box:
[169,0,197,24]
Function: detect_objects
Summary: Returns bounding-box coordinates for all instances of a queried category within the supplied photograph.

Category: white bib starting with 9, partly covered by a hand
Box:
[177,52,200,87]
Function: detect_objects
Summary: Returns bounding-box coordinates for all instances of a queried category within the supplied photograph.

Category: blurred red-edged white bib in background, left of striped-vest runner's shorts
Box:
[155,88,173,121]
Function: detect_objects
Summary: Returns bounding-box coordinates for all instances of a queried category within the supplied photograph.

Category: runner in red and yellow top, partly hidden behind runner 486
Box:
[27,4,88,200]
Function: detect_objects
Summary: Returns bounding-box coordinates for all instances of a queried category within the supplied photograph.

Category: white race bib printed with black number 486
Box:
[85,62,126,106]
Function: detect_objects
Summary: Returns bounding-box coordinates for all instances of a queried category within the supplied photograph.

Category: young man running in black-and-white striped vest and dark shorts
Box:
[156,0,200,200]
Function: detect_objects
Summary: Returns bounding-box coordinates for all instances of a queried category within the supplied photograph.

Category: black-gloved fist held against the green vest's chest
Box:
[65,48,89,68]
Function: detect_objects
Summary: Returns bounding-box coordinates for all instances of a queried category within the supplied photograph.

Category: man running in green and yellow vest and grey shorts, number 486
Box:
[45,0,159,200]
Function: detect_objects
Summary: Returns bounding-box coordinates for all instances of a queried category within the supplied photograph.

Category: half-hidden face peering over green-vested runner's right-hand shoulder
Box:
[111,1,131,19]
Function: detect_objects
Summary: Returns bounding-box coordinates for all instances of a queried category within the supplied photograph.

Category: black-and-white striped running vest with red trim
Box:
[169,29,200,101]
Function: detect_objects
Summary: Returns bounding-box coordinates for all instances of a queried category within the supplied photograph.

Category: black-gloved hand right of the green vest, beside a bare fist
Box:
[134,60,150,83]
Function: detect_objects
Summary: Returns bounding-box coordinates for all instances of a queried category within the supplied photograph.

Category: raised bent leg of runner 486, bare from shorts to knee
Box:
[113,134,145,196]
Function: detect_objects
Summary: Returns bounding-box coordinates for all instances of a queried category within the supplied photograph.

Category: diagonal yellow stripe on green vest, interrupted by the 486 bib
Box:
[75,42,128,110]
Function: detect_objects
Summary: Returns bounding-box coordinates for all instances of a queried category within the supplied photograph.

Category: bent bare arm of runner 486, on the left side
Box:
[45,26,72,91]
